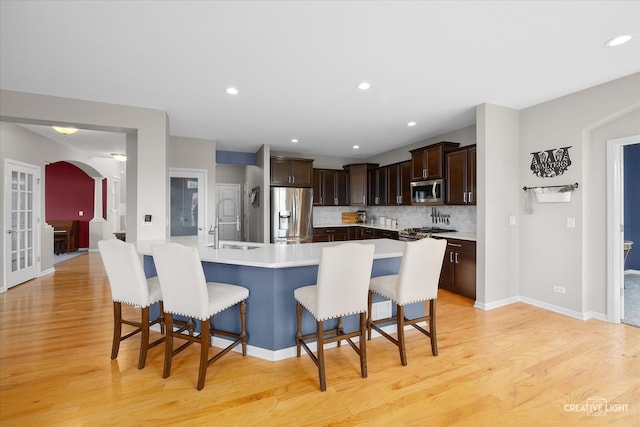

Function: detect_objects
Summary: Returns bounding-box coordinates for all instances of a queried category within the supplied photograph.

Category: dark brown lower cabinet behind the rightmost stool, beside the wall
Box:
[440,239,476,300]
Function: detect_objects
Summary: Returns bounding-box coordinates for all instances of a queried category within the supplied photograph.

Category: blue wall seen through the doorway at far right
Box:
[624,144,640,270]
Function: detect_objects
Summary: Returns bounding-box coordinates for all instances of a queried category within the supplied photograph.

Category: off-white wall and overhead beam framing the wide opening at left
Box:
[0,90,169,244]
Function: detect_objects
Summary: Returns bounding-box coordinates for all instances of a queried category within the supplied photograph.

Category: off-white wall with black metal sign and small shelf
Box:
[518,73,640,318]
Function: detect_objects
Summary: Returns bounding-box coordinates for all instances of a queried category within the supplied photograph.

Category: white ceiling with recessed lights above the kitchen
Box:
[0,0,640,158]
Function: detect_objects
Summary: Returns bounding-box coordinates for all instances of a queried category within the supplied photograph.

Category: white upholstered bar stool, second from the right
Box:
[294,243,375,391]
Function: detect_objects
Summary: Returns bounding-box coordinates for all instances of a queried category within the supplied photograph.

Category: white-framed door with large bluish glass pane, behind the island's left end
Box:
[169,168,207,236]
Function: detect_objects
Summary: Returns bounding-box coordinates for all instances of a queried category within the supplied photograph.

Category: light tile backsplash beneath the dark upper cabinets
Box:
[313,206,477,233]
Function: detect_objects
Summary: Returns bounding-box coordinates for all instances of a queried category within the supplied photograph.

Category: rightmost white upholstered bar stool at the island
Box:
[367,238,447,366]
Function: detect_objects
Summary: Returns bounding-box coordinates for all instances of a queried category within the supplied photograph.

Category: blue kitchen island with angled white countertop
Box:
[136,236,424,360]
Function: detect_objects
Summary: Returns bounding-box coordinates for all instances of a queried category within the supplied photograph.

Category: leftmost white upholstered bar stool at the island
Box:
[98,239,164,369]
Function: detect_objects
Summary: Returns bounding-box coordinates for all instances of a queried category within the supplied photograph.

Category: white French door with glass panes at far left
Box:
[0,160,40,291]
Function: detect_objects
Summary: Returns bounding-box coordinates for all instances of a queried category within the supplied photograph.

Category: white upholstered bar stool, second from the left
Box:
[152,243,249,390]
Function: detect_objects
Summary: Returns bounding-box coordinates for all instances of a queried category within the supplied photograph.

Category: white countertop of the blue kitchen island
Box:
[136,236,404,268]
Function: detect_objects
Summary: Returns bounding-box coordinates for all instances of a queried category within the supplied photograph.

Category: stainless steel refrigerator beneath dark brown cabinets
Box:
[271,187,313,243]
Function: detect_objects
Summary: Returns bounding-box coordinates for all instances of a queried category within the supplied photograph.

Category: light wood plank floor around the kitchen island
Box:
[0,253,640,426]
